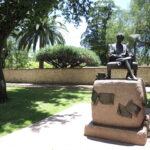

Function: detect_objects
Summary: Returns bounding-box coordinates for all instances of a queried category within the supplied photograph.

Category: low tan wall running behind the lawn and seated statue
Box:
[3,67,150,85]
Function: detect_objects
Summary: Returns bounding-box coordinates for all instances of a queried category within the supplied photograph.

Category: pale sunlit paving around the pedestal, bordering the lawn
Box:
[0,104,150,150]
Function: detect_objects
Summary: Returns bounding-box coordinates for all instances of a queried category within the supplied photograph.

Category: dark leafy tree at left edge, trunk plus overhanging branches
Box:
[0,0,92,102]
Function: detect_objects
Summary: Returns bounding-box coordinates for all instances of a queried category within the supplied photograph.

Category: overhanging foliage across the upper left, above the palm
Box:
[0,0,92,51]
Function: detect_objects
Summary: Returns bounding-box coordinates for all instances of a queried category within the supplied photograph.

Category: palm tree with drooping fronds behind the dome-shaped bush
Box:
[18,17,67,68]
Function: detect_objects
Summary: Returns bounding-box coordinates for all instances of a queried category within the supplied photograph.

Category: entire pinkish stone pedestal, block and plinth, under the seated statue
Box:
[85,79,149,145]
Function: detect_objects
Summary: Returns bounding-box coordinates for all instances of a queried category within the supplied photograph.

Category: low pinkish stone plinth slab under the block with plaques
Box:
[84,116,150,145]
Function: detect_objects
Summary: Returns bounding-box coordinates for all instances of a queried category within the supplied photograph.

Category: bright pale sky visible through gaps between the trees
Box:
[63,0,130,47]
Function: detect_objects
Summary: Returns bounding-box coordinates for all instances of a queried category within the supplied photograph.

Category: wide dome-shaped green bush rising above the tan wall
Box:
[36,45,100,68]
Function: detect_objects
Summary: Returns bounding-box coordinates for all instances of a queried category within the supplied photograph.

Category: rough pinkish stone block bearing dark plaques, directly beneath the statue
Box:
[92,79,146,127]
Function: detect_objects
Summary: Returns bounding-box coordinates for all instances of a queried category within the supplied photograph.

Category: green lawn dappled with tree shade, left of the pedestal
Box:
[0,87,91,136]
